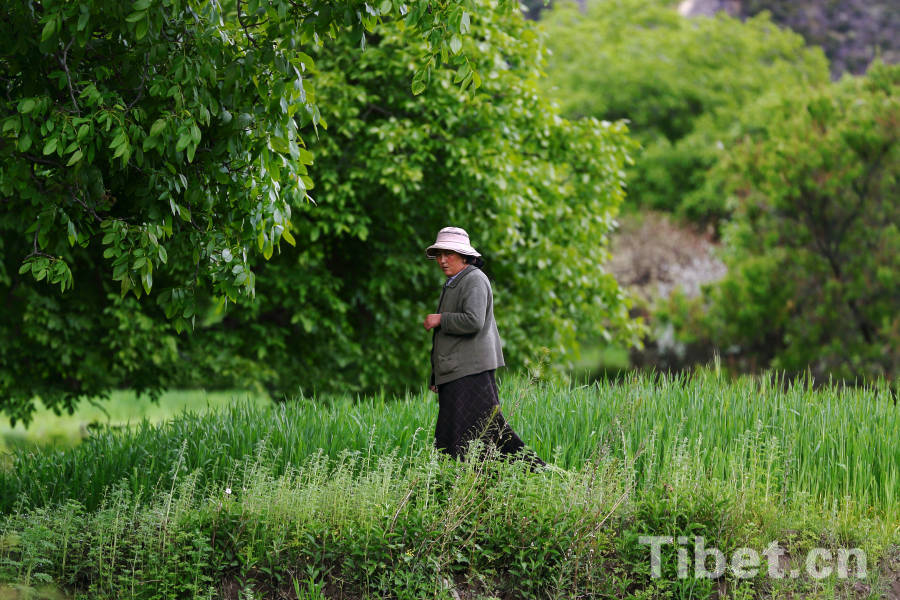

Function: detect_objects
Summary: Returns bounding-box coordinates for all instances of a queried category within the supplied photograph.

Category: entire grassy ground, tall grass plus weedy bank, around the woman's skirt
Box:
[0,371,900,598]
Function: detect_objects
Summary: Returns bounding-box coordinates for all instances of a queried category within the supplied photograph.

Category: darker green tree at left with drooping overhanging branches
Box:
[0,0,506,419]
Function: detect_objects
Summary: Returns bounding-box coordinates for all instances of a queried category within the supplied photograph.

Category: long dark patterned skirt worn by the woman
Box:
[434,371,545,466]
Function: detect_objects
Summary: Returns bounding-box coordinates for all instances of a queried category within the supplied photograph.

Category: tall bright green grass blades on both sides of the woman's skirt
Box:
[0,371,900,521]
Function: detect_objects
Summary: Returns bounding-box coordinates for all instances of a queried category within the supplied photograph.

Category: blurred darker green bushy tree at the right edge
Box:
[664,64,900,380]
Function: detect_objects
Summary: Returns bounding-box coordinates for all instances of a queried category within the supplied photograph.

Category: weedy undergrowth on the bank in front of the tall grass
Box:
[0,424,897,599]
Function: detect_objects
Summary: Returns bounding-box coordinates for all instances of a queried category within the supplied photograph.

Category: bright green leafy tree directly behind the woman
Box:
[176,5,635,396]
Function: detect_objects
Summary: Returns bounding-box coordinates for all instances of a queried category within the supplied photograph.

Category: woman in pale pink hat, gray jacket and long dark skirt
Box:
[424,227,545,466]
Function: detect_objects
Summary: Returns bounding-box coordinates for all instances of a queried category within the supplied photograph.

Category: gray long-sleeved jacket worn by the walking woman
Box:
[431,265,506,385]
